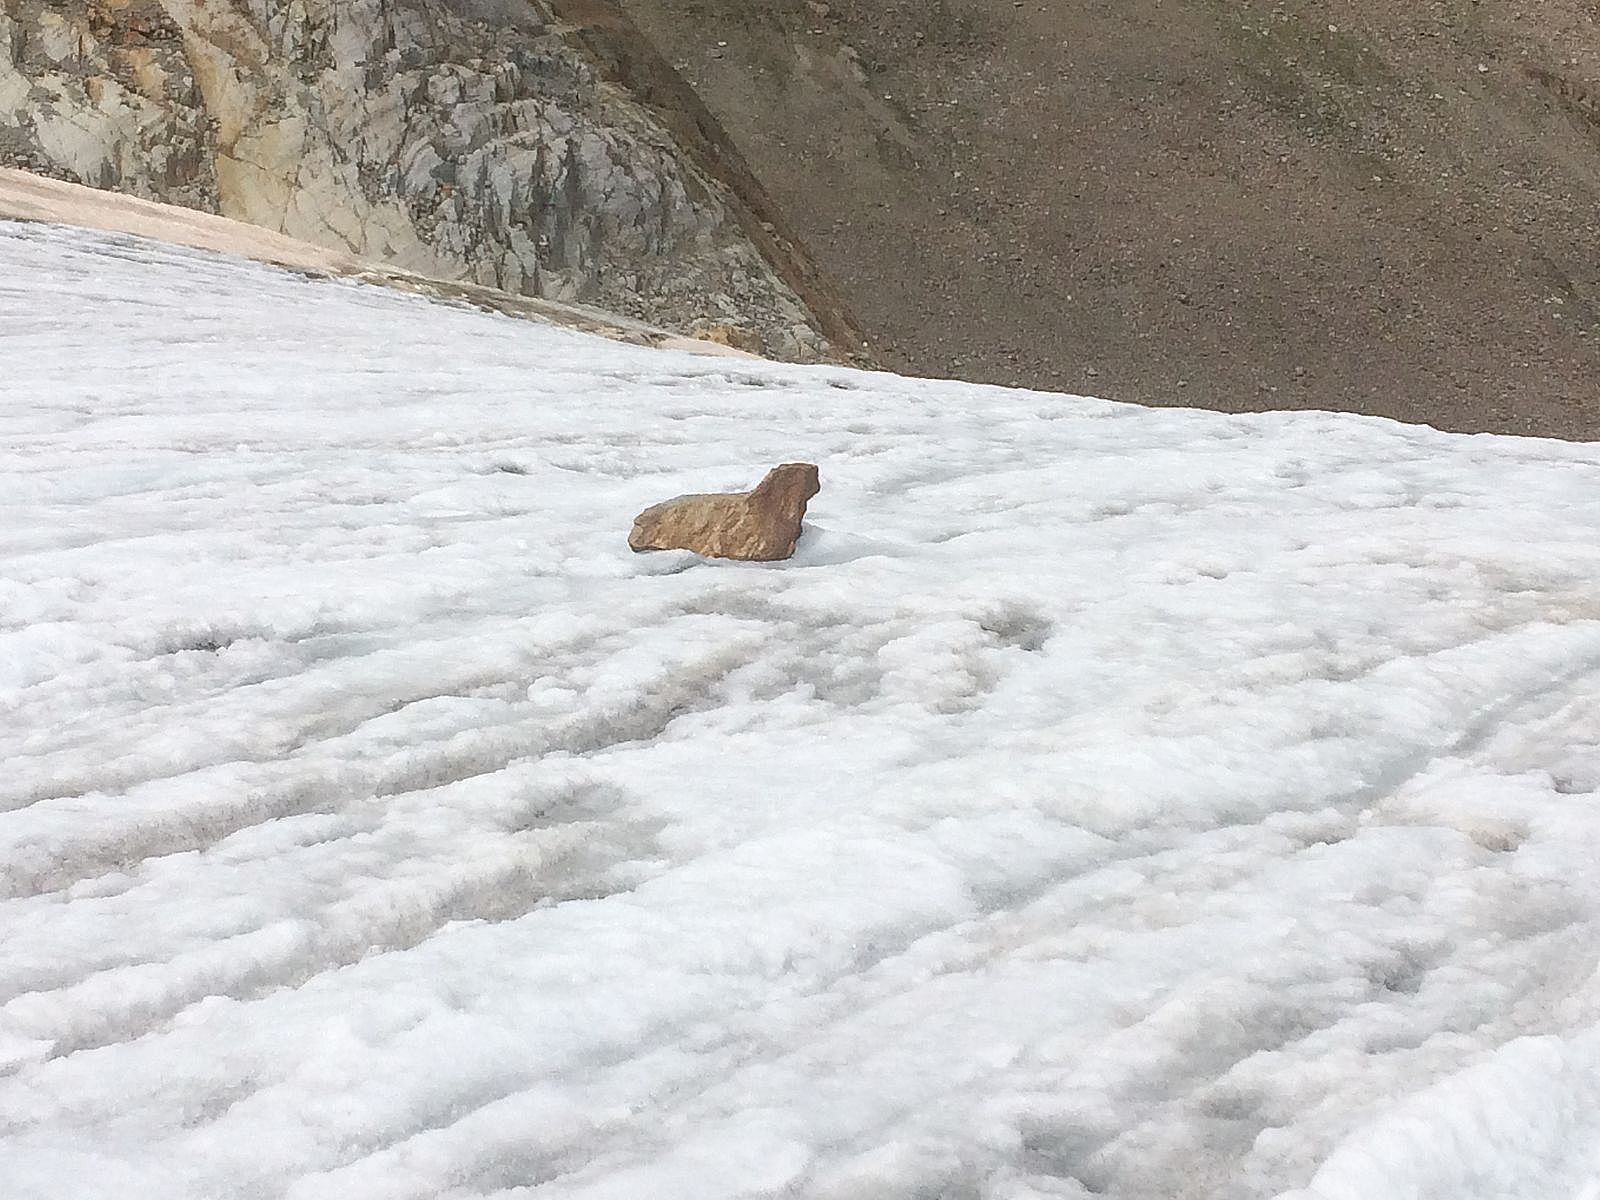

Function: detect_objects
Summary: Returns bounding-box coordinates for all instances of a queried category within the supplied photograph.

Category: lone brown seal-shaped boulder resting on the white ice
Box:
[627,462,822,562]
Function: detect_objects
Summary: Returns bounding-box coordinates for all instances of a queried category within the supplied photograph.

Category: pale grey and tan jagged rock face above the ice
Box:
[0,0,848,360]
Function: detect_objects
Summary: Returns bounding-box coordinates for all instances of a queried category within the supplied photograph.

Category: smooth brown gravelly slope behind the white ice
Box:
[622,0,1600,437]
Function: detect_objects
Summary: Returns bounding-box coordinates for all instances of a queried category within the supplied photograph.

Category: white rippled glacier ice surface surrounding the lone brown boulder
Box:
[0,226,1600,1200]
